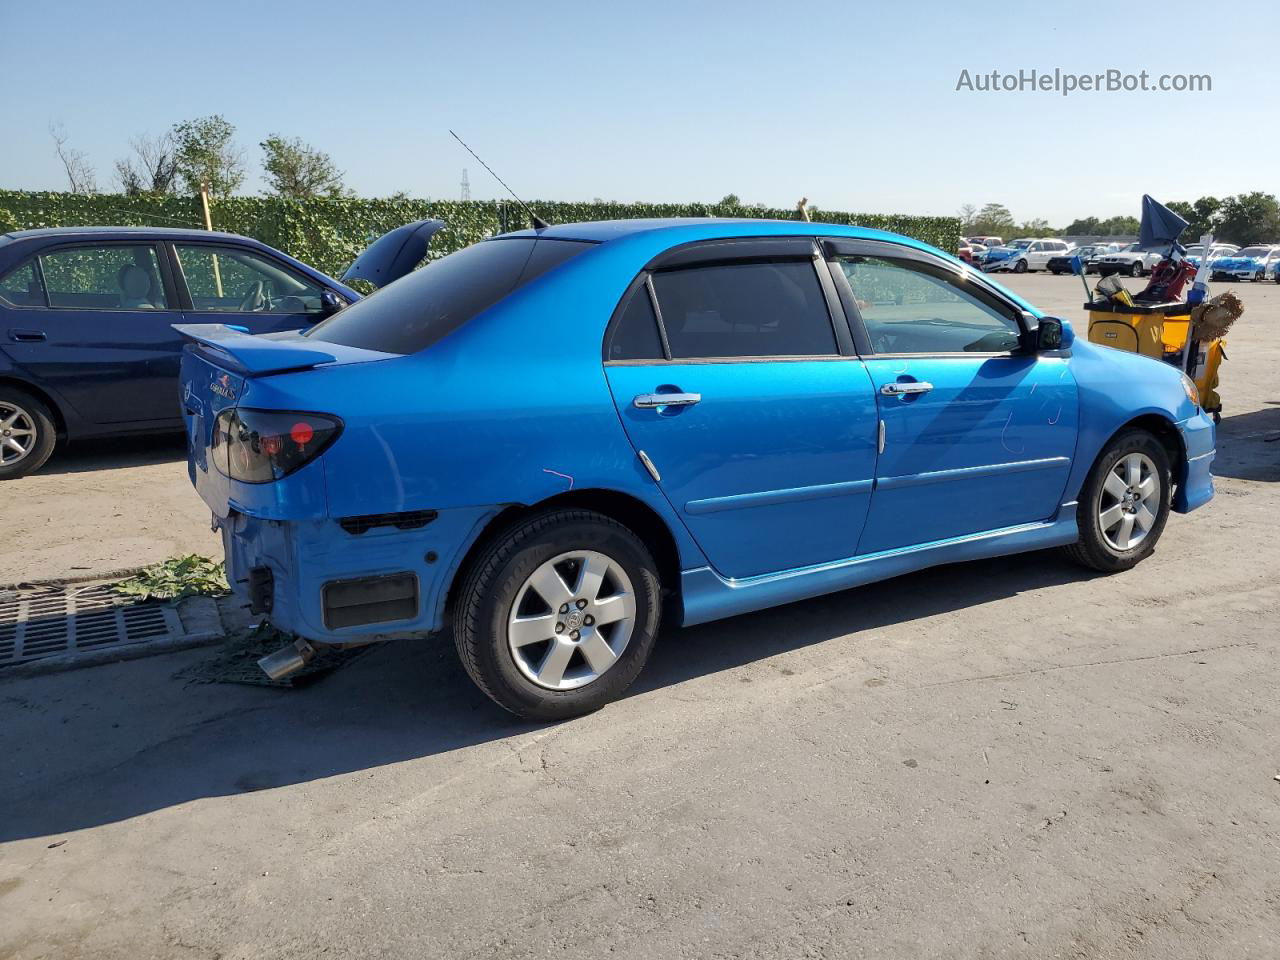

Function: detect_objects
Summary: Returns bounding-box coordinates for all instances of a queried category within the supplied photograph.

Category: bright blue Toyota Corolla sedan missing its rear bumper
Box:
[182,220,1213,719]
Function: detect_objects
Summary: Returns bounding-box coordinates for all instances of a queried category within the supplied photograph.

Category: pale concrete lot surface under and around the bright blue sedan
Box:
[0,275,1280,960]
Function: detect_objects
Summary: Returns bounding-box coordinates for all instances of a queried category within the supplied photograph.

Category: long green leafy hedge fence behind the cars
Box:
[0,191,960,275]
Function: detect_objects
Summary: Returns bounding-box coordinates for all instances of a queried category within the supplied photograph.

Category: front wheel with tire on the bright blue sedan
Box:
[1066,430,1172,573]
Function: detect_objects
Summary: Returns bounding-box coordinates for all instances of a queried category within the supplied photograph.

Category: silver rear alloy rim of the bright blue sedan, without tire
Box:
[507,550,636,690]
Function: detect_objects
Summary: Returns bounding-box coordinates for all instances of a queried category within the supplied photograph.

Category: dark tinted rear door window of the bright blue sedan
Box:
[653,260,838,360]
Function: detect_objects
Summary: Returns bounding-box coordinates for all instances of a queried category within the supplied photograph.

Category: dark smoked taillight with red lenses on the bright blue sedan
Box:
[210,407,342,484]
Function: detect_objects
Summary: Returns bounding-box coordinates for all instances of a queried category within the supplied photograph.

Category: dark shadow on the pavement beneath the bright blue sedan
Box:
[0,552,1091,841]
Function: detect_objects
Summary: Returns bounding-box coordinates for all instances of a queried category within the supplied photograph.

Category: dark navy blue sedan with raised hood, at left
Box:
[0,220,443,480]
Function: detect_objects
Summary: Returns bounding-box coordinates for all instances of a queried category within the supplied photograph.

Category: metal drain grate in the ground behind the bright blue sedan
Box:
[0,584,184,667]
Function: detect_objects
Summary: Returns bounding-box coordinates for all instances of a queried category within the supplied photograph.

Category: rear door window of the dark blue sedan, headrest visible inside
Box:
[40,243,169,310]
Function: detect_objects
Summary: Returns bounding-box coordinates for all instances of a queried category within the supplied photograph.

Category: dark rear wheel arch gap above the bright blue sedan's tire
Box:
[444,488,684,623]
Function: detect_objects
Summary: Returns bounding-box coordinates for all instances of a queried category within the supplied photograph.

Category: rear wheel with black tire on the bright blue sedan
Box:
[453,509,662,721]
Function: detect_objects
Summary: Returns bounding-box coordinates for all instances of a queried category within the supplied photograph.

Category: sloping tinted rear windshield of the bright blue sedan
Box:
[306,237,595,353]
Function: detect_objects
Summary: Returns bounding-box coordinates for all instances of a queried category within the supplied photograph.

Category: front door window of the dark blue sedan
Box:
[174,243,324,314]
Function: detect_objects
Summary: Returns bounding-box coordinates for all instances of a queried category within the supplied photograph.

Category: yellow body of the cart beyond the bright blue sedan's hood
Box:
[1084,303,1226,420]
